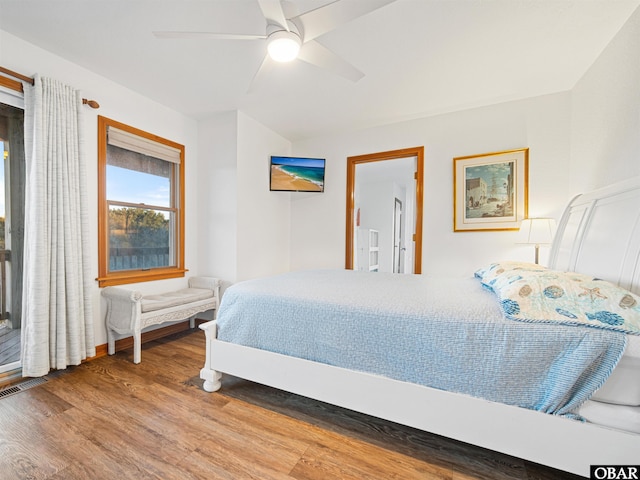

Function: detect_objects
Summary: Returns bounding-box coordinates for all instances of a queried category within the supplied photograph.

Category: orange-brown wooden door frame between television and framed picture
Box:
[345,147,424,273]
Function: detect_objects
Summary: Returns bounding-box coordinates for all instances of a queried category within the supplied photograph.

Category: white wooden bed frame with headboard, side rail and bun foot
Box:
[200,177,640,477]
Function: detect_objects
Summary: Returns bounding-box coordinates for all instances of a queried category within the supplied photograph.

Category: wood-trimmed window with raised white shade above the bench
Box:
[98,116,185,287]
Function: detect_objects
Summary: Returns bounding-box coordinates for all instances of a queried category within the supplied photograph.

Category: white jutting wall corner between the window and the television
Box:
[197,112,291,288]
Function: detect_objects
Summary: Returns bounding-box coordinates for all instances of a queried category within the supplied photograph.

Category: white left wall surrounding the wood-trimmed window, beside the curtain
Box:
[0,30,199,345]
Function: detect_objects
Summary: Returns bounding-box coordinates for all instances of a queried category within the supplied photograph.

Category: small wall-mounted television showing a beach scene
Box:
[269,155,325,192]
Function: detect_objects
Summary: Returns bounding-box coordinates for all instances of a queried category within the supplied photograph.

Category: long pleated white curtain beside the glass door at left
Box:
[22,75,95,377]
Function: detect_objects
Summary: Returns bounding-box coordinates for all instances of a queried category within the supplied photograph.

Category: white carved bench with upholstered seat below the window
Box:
[102,277,220,363]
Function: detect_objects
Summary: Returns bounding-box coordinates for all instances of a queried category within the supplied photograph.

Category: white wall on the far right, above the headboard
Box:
[571,5,640,193]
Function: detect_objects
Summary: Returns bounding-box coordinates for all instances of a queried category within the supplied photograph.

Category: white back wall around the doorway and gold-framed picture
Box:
[291,92,571,275]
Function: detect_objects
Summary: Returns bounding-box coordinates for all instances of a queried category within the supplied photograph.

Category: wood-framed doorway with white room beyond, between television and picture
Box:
[345,147,424,273]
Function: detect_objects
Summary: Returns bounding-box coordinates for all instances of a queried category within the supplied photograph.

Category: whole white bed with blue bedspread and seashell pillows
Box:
[200,178,640,476]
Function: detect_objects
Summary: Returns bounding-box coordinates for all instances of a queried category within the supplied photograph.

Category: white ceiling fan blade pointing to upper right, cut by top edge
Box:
[292,0,395,42]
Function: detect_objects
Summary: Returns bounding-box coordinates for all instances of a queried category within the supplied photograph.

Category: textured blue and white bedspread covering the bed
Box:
[217,270,626,416]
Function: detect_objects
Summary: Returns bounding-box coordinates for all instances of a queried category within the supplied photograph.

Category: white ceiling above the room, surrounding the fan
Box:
[0,0,640,140]
